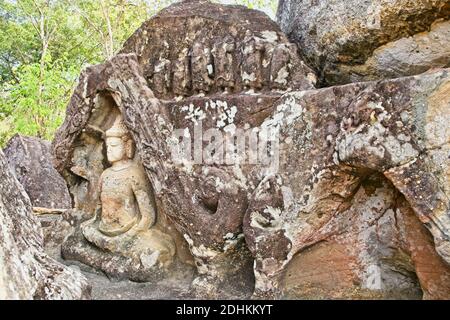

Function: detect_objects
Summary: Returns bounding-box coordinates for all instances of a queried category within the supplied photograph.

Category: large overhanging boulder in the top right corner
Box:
[277,0,450,85]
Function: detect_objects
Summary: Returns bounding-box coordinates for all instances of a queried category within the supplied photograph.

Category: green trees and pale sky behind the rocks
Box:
[0,0,278,147]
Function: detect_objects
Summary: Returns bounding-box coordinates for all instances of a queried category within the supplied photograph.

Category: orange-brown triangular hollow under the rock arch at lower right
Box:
[282,174,450,299]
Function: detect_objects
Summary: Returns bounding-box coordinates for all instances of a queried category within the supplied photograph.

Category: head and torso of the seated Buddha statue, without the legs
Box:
[99,118,155,236]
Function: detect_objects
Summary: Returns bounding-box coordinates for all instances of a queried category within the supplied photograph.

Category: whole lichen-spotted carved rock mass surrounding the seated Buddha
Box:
[53,1,450,298]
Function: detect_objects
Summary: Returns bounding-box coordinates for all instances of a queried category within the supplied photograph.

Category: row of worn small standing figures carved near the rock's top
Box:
[148,30,310,99]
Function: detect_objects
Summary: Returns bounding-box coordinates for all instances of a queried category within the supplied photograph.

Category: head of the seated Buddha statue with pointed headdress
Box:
[105,116,135,164]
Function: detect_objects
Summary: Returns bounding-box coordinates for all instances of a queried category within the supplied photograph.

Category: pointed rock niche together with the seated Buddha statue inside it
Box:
[62,93,193,281]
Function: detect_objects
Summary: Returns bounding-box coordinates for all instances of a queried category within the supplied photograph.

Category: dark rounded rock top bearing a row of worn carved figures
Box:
[121,0,316,99]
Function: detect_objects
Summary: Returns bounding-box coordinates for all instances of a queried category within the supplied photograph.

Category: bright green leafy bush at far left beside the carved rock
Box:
[0,56,79,144]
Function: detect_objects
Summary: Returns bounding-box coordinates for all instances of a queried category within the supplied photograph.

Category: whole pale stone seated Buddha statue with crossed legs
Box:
[82,116,175,265]
